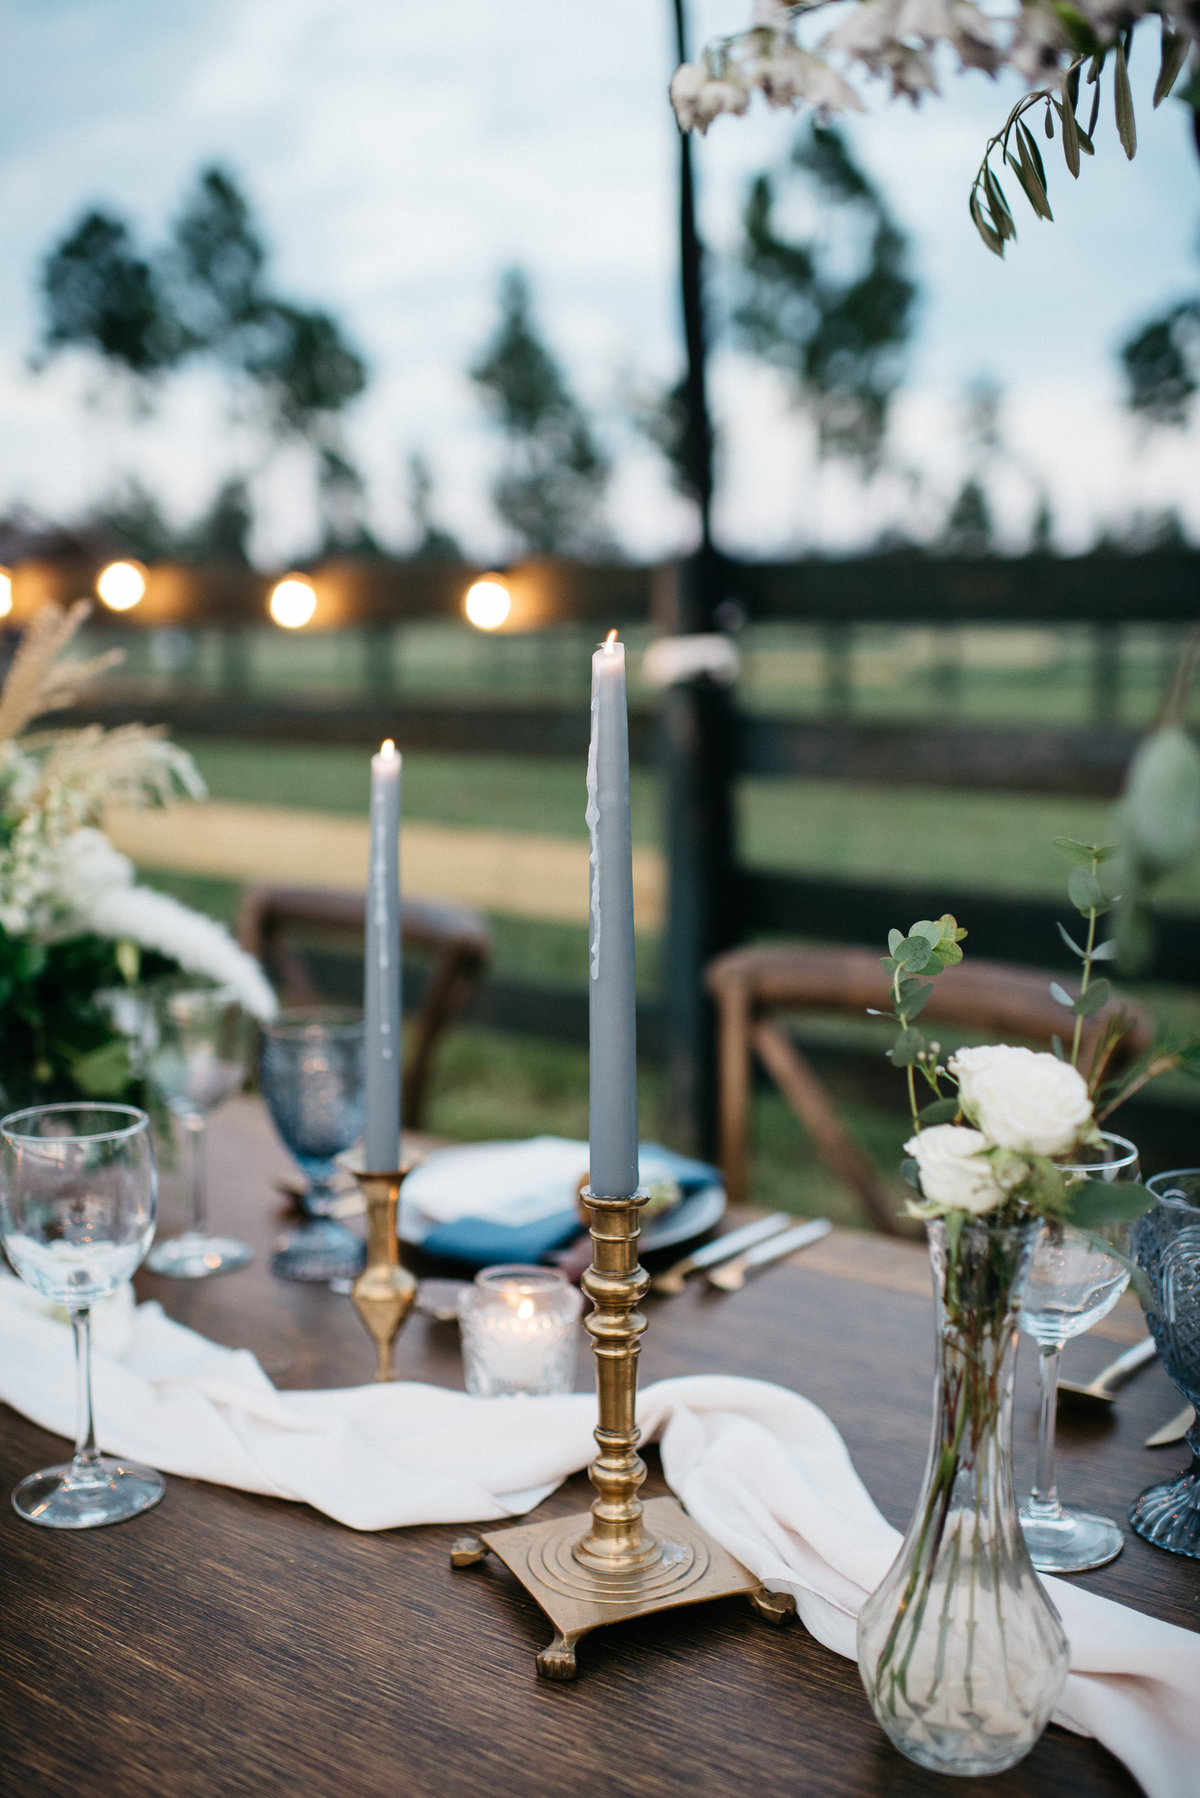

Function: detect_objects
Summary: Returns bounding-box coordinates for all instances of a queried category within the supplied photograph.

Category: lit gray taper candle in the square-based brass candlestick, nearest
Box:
[587,631,637,1199]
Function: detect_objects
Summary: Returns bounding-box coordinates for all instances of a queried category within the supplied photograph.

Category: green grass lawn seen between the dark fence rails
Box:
[148,741,1200,1224]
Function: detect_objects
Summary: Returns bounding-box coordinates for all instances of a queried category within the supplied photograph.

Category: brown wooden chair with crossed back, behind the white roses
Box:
[705,944,1153,1233]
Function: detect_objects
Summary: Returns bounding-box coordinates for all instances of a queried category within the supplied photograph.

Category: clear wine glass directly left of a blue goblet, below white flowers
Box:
[146,982,254,1280]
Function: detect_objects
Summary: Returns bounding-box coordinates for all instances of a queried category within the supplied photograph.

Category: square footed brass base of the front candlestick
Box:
[452,1498,795,1679]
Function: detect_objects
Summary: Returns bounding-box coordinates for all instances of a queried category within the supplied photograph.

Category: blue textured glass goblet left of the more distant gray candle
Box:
[259,1007,365,1282]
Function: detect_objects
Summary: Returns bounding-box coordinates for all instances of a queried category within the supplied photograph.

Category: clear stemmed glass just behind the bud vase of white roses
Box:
[1020,1131,1139,1573]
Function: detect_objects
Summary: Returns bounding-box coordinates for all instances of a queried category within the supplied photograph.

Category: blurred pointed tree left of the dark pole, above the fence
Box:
[470,268,608,554]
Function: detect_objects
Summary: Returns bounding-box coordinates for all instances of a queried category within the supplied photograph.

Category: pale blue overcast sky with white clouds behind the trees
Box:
[0,0,1200,565]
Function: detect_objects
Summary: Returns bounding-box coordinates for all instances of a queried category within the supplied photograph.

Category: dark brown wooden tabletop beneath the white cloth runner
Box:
[0,1100,1200,1798]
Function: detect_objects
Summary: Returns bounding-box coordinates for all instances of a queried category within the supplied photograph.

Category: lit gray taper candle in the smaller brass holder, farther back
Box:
[363,737,403,1174]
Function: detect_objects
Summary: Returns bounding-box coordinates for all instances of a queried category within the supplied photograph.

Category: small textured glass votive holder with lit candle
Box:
[459,1264,583,1399]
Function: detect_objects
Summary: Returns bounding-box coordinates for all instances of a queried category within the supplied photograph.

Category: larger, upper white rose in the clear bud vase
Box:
[950,1043,1092,1154]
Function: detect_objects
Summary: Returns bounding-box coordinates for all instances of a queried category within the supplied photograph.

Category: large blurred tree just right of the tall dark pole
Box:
[734,124,918,473]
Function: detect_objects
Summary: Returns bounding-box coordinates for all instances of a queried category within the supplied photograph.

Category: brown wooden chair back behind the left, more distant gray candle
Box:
[237,886,491,1129]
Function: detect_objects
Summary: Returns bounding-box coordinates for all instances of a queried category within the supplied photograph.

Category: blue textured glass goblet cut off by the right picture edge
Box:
[1130,1167,1200,1561]
